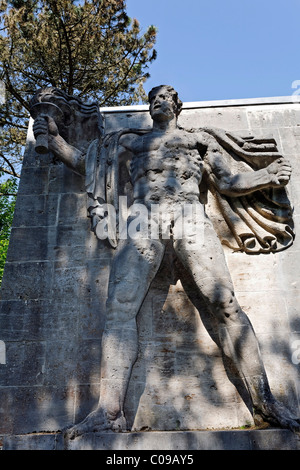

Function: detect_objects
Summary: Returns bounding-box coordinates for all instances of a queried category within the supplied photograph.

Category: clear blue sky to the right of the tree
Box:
[126,0,300,102]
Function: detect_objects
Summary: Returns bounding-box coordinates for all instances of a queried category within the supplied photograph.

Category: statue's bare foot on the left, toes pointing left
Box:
[64,410,127,439]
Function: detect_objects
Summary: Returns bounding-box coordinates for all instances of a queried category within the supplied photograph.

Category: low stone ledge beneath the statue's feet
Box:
[0,429,300,452]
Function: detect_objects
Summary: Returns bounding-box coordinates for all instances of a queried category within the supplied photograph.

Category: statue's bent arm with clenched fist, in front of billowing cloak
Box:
[204,143,292,197]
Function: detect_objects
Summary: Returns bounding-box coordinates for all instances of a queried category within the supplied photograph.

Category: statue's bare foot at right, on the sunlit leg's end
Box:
[254,400,300,433]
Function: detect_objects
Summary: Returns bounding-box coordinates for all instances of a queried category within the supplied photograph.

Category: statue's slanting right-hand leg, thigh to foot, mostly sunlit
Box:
[174,218,300,431]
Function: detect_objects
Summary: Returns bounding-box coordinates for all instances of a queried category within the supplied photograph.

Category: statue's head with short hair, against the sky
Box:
[148,85,182,120]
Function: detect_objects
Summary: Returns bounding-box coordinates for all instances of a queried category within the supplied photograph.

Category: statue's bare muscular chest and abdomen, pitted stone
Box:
[121,129,203,206]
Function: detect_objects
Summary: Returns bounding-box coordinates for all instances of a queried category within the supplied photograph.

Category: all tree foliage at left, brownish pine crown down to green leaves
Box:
[0,0,156,277]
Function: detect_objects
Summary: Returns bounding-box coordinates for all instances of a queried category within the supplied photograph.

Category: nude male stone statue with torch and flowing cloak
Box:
[32,85,300,438]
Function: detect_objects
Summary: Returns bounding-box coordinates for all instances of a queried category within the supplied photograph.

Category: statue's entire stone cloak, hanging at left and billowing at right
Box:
[86,128,294,253]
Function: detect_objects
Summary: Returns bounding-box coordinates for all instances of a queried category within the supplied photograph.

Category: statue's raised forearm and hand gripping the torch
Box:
[33,115,85,175]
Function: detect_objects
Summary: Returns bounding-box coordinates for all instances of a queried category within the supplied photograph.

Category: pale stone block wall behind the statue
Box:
[0,96,300,434]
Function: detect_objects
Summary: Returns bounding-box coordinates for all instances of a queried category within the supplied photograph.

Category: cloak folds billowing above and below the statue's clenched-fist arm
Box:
[203,128,295,254]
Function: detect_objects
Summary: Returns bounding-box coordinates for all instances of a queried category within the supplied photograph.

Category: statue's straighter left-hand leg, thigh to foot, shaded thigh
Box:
[67,239,165,438]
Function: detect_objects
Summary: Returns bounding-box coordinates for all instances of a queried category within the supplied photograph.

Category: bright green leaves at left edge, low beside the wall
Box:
[0,178,17,285]
